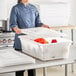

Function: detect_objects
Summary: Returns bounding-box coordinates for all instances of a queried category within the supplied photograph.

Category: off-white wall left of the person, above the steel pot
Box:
[0,0,16,20]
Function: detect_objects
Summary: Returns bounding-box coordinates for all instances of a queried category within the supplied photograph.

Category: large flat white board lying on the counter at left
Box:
[0,48,35,68]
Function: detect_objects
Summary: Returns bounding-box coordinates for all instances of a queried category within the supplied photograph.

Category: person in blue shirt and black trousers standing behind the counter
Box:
[10,0,49,76]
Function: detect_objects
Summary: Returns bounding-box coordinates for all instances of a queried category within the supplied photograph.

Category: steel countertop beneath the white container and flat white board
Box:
[0,46,76,76]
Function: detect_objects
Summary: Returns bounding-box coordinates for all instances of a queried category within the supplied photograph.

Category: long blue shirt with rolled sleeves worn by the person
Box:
[10,2,43,49]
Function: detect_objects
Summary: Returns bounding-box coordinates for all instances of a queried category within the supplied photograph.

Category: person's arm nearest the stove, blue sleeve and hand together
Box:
[10,7,21,34]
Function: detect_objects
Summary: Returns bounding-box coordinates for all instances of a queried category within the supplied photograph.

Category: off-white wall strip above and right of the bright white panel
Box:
[29,0,76,25]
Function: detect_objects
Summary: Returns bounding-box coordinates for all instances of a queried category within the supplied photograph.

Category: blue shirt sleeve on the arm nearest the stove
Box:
[10,7,17,29]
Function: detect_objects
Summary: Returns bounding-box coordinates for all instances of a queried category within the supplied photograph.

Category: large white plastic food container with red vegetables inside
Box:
[19,28,72,61]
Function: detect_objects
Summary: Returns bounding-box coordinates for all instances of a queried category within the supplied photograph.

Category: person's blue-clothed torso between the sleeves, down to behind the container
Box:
[14,3,36,49]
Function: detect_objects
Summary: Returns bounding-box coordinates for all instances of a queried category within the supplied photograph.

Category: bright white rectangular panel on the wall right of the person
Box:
[40,3,70,26]
